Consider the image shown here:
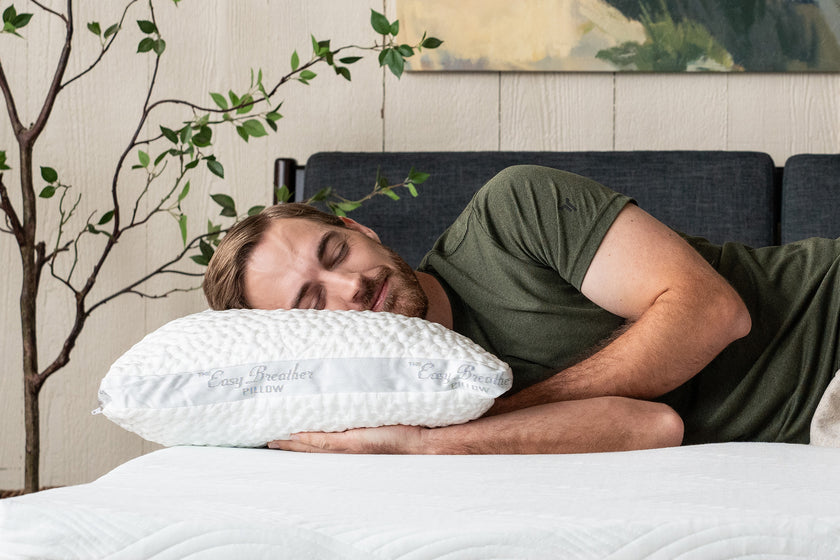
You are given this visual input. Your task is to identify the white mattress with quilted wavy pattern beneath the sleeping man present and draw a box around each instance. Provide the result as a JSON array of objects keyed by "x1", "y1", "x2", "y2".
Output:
[{"x1": 0, "y1": 443, "x2": 840, "y2": 560}]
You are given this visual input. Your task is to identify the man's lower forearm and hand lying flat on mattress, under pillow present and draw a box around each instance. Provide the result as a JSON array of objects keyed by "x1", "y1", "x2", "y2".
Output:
[{"x1": 269, "y1": 397, "x2": 683, "y2": 455}]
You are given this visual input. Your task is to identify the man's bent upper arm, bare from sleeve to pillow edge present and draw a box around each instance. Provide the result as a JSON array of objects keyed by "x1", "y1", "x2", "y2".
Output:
[{"x1": 491, "y1": 205, "x2": 751, "y2": 414}]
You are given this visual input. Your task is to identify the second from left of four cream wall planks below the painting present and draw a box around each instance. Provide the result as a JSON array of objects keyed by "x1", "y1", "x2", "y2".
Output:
[{"x1": 499, "y1": 73, "x2": 613, "y2": 151}]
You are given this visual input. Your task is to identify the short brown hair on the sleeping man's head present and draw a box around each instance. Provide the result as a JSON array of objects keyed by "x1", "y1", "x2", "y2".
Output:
[{"x1": 202, "y1": 202, "x2": 346, "y2": 310}]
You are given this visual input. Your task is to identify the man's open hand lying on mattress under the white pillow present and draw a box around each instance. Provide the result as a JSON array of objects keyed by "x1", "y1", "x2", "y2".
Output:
[{"x1": 268, "y1": 426, "x2": 428, "y2": 454}]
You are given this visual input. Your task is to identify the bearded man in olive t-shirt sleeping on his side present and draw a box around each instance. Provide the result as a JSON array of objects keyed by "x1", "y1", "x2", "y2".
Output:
[{"x1": 205, "y1": 166, "x2": 840, "y2": 453}]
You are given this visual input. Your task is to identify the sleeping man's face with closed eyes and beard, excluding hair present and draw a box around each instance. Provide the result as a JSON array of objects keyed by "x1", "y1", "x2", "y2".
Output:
[{"x1": 245, "y1": 218, "x2": 428, "y2": 317}]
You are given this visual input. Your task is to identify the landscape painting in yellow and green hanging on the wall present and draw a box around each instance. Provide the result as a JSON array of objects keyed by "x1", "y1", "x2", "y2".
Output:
[{"x1": 397, "y1": 0, "x2": 840, "y2": 72}]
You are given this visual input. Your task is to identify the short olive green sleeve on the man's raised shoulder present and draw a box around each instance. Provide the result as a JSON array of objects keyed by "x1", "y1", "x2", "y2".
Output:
[{"x1": 470, "y1": 165, "x2": 631, "y2": 290}]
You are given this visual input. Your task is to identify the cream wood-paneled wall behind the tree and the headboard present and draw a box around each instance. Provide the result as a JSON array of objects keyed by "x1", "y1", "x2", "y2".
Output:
[{"x1": 0, "y1": 0, "x2": 840, "y2": 488}]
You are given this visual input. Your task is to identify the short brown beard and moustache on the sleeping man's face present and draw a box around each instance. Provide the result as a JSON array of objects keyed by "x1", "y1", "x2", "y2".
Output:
[{"x1": 365, "y1": 245, "x2": 429, "y2": 319}]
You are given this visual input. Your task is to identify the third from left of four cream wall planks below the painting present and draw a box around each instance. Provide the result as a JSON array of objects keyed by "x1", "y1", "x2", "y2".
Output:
[{"x1": 615, "y1": 74, "x2": 726, "y2": 150}]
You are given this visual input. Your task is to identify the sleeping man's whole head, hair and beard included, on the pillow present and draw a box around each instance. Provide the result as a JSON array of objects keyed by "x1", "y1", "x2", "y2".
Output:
[{"x1": 204, "y1": 203, "x2": 428, "y2": 317}]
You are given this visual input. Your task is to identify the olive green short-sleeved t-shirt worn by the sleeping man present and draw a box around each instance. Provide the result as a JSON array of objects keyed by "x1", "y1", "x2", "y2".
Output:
[{"x1": 419, "y1": 166, "x2": 840, "y2": 443}]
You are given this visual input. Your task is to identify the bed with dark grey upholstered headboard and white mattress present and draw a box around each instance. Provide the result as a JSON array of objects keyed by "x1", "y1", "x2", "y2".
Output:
[{"x1": 0, "y1": 152, "x2": 840, "y2": 560}]
